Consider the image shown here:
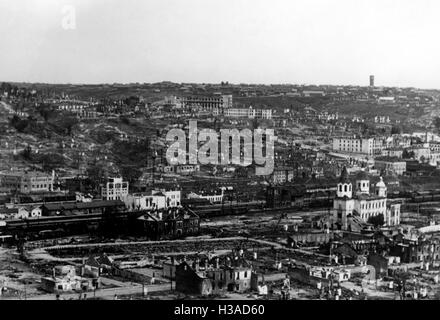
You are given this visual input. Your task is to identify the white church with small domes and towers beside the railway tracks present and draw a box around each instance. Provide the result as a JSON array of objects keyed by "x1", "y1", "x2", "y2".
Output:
[{"x1": 333, "y1": 168, "x2": 400, "y2": 231}]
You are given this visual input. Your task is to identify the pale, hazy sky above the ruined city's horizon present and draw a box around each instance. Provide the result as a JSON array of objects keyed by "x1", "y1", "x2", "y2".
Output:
[{"x1": 0, "y1": 0, "x2": 440, "y2": 89}]
